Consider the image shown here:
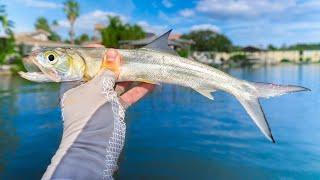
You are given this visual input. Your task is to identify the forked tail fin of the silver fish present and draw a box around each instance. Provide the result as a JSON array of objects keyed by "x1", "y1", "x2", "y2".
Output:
[{"x1": 236, "y1": 82, "x2": 310, "y2": 143}]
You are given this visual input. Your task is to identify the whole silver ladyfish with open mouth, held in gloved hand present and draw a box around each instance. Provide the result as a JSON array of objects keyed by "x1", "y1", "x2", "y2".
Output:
[{"x1": 20, "y1": 30, "x2": 309, "y2": 142}]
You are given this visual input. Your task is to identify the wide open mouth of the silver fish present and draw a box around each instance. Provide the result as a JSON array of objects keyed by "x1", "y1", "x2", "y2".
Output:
[{"x1": 19, "y1": 53, "x2": 61, "y2": 82}]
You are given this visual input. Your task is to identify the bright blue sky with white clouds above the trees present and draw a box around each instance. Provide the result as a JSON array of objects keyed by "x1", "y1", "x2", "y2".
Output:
[{"x1": 2, "y1": 0, "x2": 320, "y2": 46}]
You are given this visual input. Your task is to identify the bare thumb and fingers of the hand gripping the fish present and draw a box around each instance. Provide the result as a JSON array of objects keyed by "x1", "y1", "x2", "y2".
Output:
[{"x1": 90, "y1": 45, "x2": 155, "y2": 107}]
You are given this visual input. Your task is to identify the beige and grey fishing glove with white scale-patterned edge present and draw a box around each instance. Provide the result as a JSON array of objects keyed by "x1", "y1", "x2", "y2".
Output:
[{"x1": 42, "y1": 70, "x2": 126, "y2": 180}]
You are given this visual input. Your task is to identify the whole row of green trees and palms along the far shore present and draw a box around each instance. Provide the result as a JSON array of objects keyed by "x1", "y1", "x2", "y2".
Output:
[{"x1": 8, "y1": 0, "x2": 320, "y2": 64}]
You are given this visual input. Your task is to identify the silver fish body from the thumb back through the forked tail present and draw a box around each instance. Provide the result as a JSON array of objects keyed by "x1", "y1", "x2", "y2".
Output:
[{"x1": 70, "y1": 48, "x2": 308, "y2": 142}]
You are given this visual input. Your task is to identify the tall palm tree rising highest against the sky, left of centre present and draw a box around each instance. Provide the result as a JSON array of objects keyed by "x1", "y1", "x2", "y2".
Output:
[{"x1": 63, "y1": 0, "x2": 79, "y2": 44}]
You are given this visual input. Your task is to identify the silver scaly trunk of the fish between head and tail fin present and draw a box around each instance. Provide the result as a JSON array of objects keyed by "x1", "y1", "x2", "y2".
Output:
[{"x1": 75, "y1": 48, "x2": 242, "y2": 93}]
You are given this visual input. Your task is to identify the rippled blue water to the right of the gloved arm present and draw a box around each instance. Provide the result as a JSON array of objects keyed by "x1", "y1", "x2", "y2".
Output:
[{"x1": 118, "y1": 65, "x2": 320, "y2": 179}]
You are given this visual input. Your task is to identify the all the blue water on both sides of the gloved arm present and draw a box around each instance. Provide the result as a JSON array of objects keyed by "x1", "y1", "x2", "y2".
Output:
[{"x1": 0, "y1": 65, "x2": 320, "y2": 179}]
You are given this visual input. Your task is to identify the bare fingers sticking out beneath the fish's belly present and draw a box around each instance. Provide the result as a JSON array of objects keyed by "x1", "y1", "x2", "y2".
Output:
[{"x1": 120, "y1": 83, "x2": 155, "y2": 106}]
